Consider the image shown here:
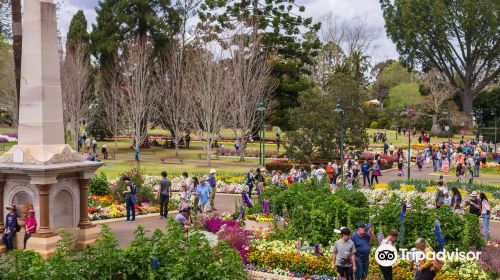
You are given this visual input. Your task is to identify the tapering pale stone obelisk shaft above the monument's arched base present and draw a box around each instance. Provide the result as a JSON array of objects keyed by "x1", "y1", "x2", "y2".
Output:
[{"x1": 0, "y1": 0, "x2": 85, "y2": 164}]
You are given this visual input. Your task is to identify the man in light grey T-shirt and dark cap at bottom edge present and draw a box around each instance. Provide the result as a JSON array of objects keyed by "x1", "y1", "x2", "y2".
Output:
[{"x1": 331, "y1": 227, "x2": 356, "y2": 280}]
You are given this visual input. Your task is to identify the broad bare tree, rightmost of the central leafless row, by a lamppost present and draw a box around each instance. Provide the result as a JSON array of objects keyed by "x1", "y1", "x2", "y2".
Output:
[{"x1": 226, "y1": 32, "x2": 276, "y2": 161}]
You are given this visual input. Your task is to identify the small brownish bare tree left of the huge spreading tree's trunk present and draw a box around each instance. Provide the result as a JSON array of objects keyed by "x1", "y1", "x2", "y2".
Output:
[{"x1": 423, "y1": 68, "x2": 455, "y2": 135}]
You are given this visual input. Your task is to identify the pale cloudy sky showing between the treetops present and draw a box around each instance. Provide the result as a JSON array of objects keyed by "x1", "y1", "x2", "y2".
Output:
[{"x1": 59, "y1": 0, "x2": 398, "y2": 61}]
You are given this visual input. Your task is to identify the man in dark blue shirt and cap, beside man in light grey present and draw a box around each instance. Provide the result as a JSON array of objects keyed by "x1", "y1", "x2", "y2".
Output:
[{"x1": 351, "y1": 223, "x2": 375, "y2": 280}]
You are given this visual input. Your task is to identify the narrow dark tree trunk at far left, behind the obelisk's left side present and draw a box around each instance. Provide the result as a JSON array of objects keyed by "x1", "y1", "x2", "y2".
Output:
[{"x1": 11, "y1": 0, "x2": 23, "y2": 124}]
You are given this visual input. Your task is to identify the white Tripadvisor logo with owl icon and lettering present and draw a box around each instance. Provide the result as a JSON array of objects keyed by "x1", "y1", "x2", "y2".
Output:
[{"x1": 375, "y1": 244, "x2": 481, "y2": 266}]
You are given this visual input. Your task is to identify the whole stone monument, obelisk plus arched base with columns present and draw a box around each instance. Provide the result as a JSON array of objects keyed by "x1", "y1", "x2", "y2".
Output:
[{"x1": 0, "y1": 0, "x2": 102, "y2": 256}]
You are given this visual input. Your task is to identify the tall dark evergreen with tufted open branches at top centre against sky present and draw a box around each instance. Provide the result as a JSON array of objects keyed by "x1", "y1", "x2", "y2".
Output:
[{"x1": 199, "y1": 0, "x2": 320, "y2": 129}]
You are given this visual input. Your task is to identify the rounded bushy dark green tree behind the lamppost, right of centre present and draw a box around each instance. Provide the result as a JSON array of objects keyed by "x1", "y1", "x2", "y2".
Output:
[{"x1": 287, "y1": 73, "x2": 368, "y2": 161}]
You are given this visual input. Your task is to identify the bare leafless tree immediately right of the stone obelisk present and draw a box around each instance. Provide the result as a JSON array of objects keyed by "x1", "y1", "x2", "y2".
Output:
[{"x1": 61, "y1": 44, "x2": 92, "y2": 149}]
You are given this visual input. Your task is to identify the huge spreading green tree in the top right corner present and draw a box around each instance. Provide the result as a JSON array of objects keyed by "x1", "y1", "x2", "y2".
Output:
[{"x1": 380, "y1": 0, "x2": 500, "y2": 127}]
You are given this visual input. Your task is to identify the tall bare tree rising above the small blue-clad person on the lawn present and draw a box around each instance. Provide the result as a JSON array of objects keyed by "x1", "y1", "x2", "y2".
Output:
[{"x1": 118, "y1": 38, "x2": 154, "y2": 163}]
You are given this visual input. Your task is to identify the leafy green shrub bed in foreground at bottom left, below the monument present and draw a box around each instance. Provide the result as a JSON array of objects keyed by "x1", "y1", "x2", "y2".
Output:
[{"x1": 0, "y1": 222, "x2": 246, "y2": 280}]
